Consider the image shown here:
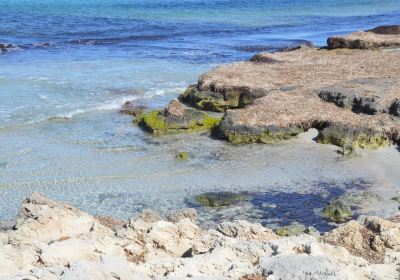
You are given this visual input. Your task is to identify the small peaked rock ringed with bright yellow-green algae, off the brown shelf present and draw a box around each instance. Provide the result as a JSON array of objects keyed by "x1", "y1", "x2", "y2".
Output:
[{"x1": 135, "y1": 100, "x2": 220, "y2": 135}]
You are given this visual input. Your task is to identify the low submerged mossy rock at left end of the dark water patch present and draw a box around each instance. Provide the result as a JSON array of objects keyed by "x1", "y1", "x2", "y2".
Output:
[{"x1": 196, "y1": 192, "x2": 249, "y2": 207}]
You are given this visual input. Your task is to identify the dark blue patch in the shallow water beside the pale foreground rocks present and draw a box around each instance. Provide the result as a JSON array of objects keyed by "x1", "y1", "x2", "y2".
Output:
[{"x1": 187, "y1": 180, "x2": 370, "y2": 233}]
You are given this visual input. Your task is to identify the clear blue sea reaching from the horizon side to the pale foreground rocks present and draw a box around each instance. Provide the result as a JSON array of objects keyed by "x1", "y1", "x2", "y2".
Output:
[{"x1": 0, "y1": 0, "x2": 400, "y2": 231}]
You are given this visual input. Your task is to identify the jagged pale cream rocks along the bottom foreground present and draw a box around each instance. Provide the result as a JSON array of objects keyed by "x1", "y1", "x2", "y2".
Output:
[{"x1": 0, "y1": 193, "x2": 400, "y2": 280}]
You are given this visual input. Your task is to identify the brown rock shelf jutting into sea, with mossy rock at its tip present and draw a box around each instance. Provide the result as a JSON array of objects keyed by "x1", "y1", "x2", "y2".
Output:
[{"x1": 129, "y1": 26, "x2": 400, "y2": 154}]
